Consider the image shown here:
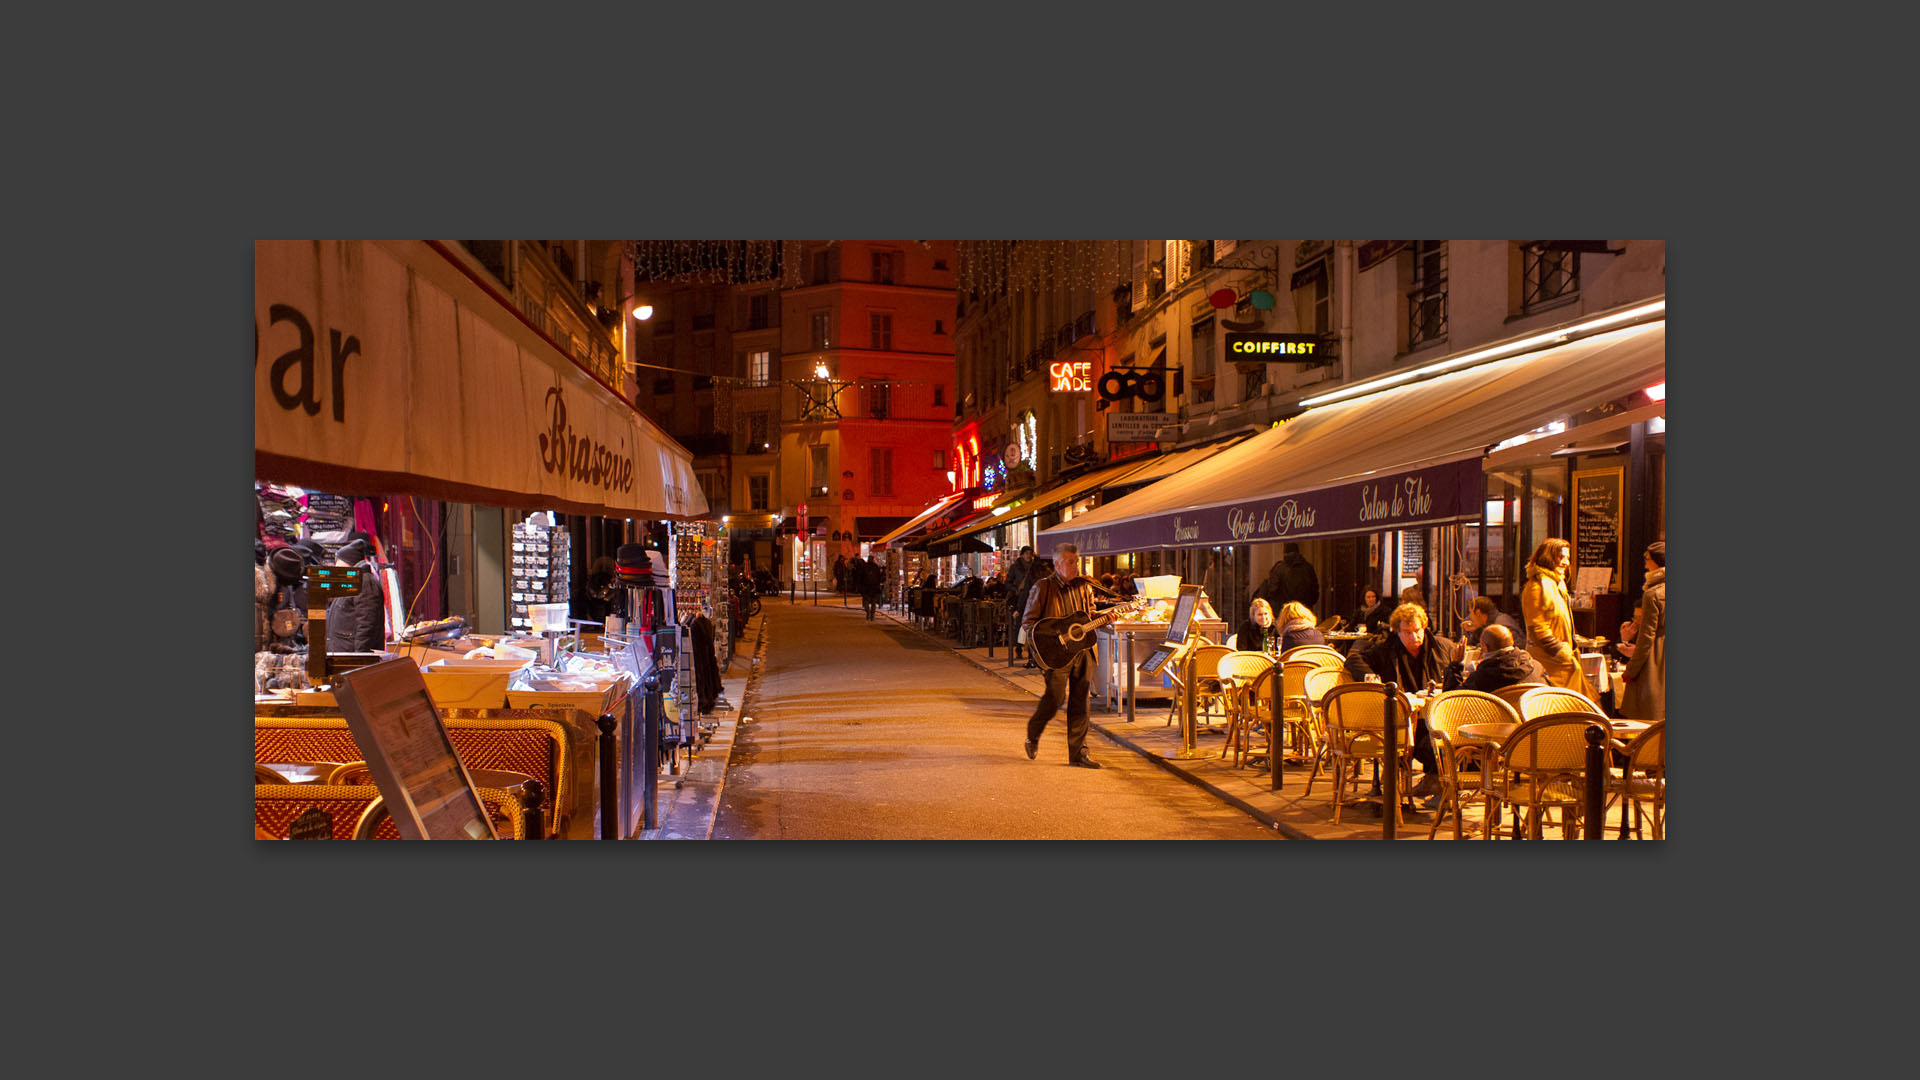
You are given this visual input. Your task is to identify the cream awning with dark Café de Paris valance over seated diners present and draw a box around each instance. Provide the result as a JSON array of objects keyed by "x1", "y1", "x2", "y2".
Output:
[{"x1": 1035, "y1": 319, "x2": 1667, "y2": 555}]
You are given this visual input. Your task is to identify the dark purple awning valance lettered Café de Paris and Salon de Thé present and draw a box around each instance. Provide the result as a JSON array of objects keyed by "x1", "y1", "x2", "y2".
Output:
[{"x1": 1044, "y1": 457, "x2": 1486, "y2": 555}]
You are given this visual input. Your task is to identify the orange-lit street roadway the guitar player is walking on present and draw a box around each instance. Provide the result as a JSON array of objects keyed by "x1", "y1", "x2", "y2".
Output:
[{"x1": 706, "y1": 598, "x2": 1277, "y2": 840}]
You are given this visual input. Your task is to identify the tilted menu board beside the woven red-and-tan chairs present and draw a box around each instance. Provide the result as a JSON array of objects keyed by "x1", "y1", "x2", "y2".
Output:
[{"x1": 334, "y1": 659, "x2": 497, "y2": 840}]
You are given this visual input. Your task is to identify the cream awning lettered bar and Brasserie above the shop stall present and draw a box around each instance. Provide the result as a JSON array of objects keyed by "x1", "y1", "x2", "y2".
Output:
[{"x1": 253, "y1": 240, "x2": 707, "y2": 519}]
